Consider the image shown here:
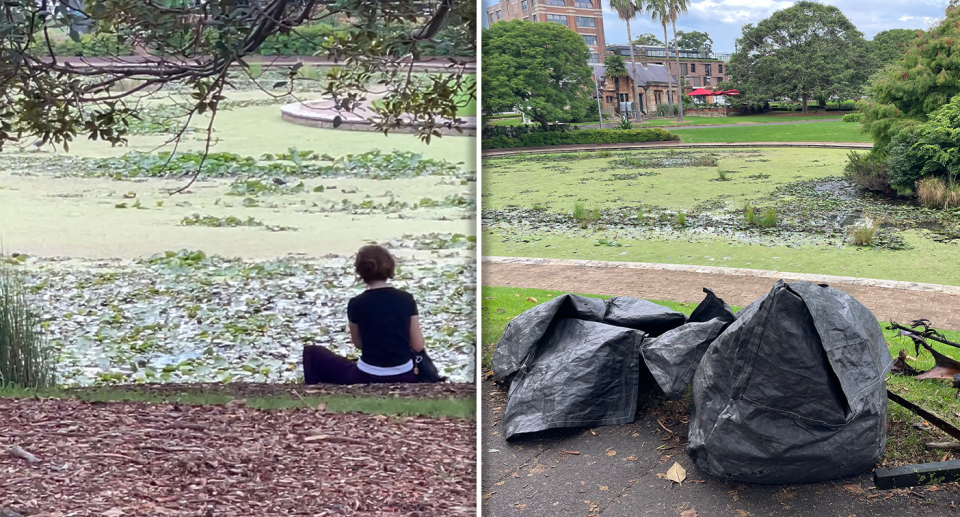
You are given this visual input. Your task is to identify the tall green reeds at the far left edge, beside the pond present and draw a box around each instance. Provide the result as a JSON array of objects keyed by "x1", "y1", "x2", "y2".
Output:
[{"x1": 0, "y1": 262, "x2": 56, "y2": 389}]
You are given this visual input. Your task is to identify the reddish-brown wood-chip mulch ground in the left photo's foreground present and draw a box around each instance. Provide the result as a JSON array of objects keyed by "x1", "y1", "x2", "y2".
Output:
[{"x1": 0, "y1": 399, "x2": 477, "y2": 517}]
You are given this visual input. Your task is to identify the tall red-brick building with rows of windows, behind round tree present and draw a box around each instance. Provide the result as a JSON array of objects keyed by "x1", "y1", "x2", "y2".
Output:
[{"x1": 486, "y1": 0, "x2": 606, "y2": 63}]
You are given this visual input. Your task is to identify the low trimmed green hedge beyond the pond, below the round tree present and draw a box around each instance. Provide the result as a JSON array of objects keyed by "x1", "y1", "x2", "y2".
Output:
[{"x1": 481, "y1": 128, "x2": 680, "y2": 149}]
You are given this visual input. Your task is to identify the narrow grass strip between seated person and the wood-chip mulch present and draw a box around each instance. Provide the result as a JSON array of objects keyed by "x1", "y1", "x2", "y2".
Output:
[{"x1": 0, "y1": 387, "x2": 476, "y2": 419}]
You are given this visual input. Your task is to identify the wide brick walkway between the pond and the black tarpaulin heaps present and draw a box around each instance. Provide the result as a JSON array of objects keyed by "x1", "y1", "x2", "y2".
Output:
[{"x1": 481, "y1": 257, "x2": 960, "y2": 330}]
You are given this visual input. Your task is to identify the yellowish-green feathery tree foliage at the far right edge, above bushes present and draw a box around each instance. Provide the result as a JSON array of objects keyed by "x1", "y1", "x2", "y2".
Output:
[{"x1": 860, "y1": 7, "x2": 960, "y2": 154}]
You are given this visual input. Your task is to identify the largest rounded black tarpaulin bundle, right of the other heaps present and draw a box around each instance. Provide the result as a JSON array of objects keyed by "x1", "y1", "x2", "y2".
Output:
[{"x1": 687, "y1": 281, "x2": 893, "y2": 484}]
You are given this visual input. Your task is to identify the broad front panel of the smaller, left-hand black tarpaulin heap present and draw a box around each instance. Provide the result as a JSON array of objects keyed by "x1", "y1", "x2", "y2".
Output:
[{"x1": 503, "y1": 318, "x2": 643, "y2": 439}]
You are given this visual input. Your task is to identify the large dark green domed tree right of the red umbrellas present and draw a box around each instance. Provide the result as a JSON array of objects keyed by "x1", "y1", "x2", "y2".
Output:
[{"x1": 728, "y1": 1, "x2": 875, "y2": 113}]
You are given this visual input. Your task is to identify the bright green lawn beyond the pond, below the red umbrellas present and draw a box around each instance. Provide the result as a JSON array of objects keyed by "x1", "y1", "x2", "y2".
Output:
[{"x1": 671, "y1": 122, "x2": 872, "y2": 142}]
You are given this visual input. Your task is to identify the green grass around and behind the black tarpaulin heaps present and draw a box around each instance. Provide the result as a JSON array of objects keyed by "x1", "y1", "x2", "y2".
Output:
[{"x1": 481, "y1": 286, "x2": 960, "y2": 465}]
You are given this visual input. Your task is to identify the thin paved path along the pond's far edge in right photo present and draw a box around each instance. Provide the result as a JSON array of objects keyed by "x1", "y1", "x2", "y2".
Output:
[{"x1": 481, "y1": 141, "x2": 873, "y2": 158}]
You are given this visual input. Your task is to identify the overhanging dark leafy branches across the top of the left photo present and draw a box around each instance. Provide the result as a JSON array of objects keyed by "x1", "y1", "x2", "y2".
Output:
[{"x1": 0, "y1": 0, "x2": 476, "y2": 153}]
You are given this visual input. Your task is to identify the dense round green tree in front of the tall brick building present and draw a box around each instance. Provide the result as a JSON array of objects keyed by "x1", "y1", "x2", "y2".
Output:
[{"x1": 480, "y1": 20, "x2": 594, "y2": 129}]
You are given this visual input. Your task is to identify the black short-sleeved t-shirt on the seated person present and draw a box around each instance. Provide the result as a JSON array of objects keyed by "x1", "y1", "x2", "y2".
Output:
[{"x1": 347, "y1": 287, "x2": 419, "y2": 368}]
